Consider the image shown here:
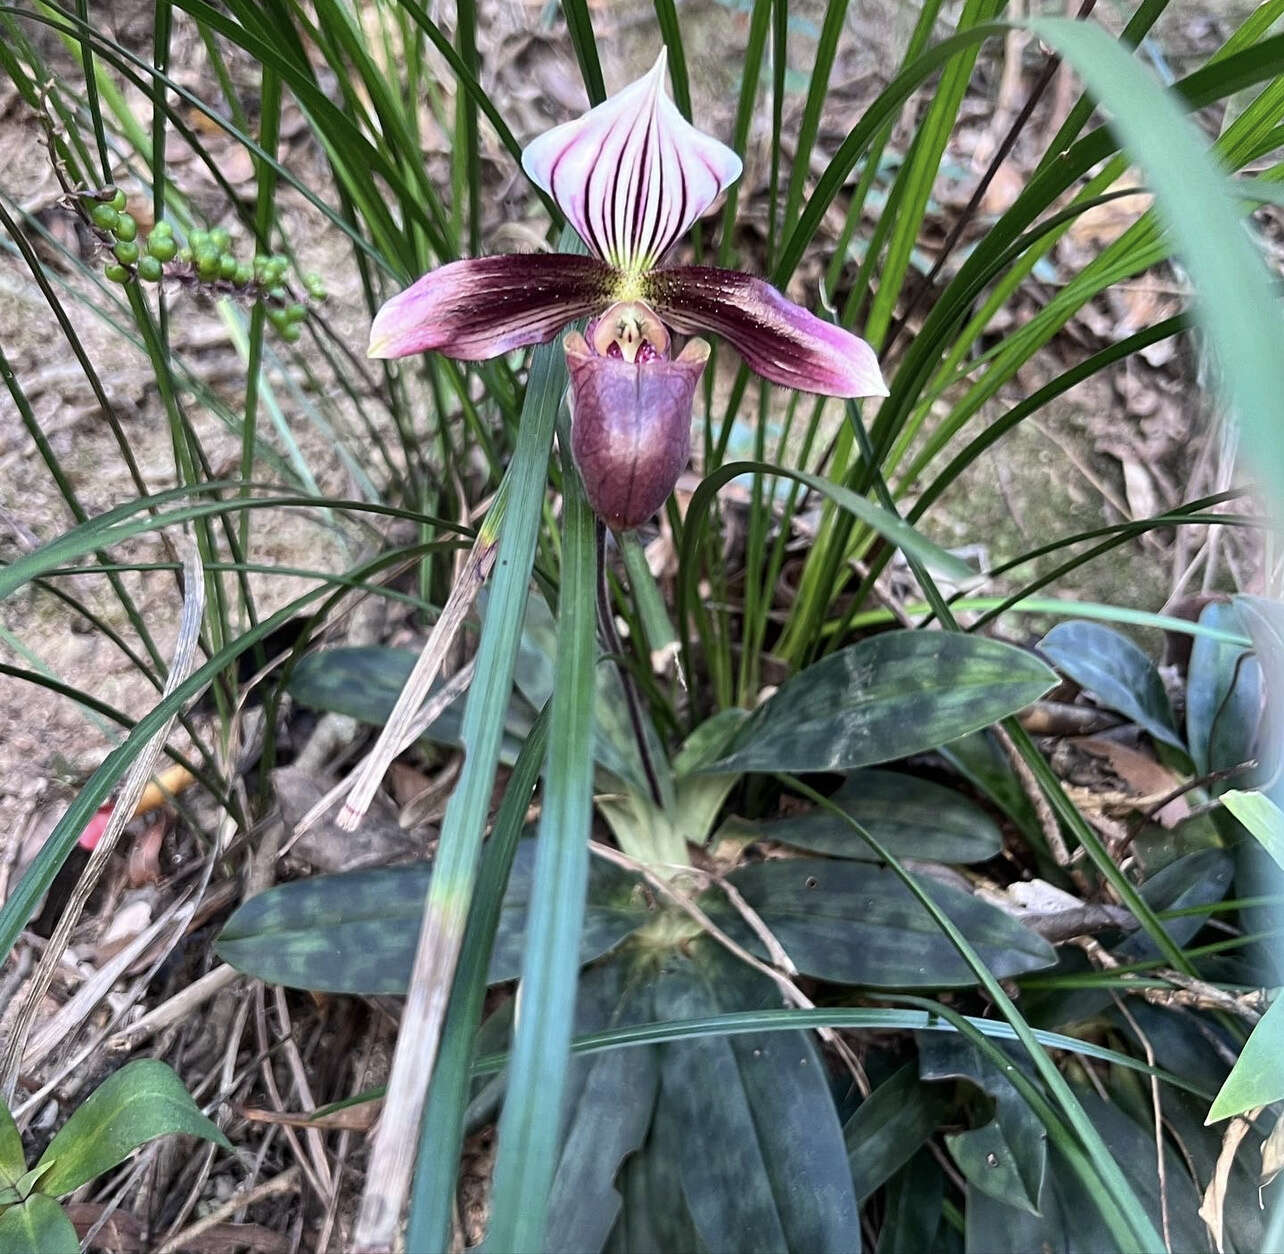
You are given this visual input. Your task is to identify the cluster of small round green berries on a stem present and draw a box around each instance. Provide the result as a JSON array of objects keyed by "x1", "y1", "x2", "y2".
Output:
[{"x1": 86, "y1": 187, "x2": 326, "y2": 344}]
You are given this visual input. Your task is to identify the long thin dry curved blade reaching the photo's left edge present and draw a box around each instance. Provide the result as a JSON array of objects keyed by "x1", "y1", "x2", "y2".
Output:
[{"x1": 0, "y1": 543, "x2": 205, "y2": 1104}]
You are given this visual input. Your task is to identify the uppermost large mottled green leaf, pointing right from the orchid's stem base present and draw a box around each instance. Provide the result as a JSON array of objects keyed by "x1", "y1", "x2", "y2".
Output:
[{"x1": 709, "y1": 631, "x2": 1057, "y2": 771}]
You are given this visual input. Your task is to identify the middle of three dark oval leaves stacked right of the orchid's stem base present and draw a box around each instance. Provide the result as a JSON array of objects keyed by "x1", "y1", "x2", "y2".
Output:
[{"x1": 737, "y1": 770, "x2": 1003, "y2": 863}]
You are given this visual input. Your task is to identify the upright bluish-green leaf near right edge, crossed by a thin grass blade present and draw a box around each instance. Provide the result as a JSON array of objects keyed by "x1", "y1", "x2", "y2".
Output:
[{"x1": 1186, "y1": 601, "x2": 1262, "y2": 787}]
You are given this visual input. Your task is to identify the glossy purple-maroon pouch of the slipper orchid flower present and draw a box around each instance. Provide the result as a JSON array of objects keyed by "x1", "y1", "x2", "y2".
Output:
[{"x1": 566, "y1": 331, "x2": 709, "y2": 531}]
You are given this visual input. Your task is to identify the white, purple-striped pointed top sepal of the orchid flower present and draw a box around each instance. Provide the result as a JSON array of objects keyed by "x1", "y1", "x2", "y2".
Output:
[{"x1": 521, "y1": 50, "x2": 741, "y2": 271}]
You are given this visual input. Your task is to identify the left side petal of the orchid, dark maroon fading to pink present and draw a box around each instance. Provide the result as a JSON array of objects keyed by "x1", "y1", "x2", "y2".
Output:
[{"x1": 369, "y1": 253, "x2": 619, "y2": 362}]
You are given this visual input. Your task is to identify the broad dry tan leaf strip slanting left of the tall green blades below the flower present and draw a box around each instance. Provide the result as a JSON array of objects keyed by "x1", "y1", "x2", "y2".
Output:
[{"x1": 338, "y1": 515, "x2": 499, "y2": 832}]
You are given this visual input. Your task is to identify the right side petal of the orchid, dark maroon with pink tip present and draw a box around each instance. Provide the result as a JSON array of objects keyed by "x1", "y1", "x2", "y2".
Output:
[{"x1": 642, "y1": 266, "x2": 887, "y2": 397}]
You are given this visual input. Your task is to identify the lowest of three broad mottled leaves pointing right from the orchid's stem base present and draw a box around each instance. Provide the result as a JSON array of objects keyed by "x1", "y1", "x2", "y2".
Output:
[{"x1": 701, "y1": 857, "x2": 1057, "y2": 988}]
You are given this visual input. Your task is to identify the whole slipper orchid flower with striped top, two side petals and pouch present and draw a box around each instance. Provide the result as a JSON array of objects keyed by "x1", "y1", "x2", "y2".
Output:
[{"x1": 370, "y1": 51, "x2": 887, "y2": 530}]
